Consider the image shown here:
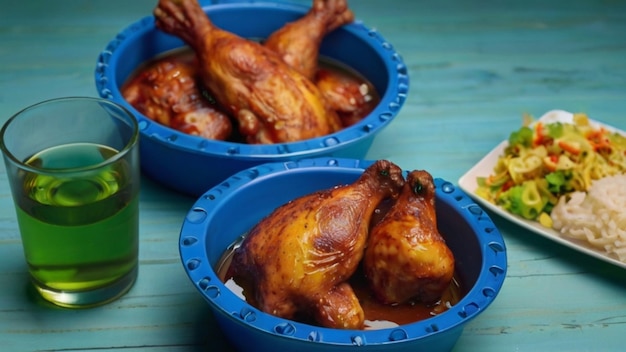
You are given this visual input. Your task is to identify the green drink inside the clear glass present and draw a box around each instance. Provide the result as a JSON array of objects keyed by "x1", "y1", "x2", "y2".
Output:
[{"x1": 16, "y1": 143, "x2": 138, "y2": 291}]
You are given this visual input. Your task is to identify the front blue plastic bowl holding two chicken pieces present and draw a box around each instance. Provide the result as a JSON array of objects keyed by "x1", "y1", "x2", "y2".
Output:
[{"x1": 179, "y1": 158, "x2": 507, "y2": 351}]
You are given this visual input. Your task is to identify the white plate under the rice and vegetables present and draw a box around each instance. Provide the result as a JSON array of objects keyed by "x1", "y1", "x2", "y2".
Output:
[{"x1": 459, "y1": 110, "x2": 626, "y2": 269}]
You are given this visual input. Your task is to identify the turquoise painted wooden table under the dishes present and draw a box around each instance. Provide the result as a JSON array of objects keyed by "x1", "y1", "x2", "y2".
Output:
[{"x1": 0, "y1": 0, "x2": 626, "y2": 352}]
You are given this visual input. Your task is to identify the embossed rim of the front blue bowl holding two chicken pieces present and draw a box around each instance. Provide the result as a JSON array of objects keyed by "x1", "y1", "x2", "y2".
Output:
[{"x1": 179, "y1": 157, "x2": 507, "y2": 346}]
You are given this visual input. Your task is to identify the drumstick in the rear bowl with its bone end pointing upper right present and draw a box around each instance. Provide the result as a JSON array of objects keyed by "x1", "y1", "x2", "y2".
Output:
[{"x1": 264, "y1": 0, "x2": 354, "y2": 80}]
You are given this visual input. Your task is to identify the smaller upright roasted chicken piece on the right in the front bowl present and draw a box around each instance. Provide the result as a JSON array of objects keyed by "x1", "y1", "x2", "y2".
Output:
[{"x1": 363, "y1": 171, "x2": 454, "y2": 304}]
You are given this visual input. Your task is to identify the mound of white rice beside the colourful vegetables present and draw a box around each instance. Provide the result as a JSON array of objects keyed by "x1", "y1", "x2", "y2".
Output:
[{"x1": 550, "y1": 174, "x2": 626, "y2": 262}]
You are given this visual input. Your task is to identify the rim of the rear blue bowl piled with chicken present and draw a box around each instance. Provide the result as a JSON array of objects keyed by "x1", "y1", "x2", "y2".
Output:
[{"x1": 95, "y1": 2, "x2": 409, "y2": 160}]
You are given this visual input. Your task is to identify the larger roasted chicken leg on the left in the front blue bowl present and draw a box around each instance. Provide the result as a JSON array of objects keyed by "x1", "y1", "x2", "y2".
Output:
[{"x1": 229, "y1": 160, "x2": 404, "y2": 329}]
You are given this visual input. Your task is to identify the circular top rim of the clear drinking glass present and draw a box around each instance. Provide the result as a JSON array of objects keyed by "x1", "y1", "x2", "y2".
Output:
[{"x1": 0, "y1": 96, "x2": 139, "y2": 174}]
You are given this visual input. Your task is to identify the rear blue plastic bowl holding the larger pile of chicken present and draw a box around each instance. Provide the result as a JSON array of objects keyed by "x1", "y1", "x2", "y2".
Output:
[{"x1": 95, "y1": 2, "x2": 409, "y2": 196}]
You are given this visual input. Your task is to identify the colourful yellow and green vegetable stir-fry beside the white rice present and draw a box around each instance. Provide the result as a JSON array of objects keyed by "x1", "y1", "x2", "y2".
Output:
[{"x1": 476, "y1": 113, "x2": 626, "y2": 227}]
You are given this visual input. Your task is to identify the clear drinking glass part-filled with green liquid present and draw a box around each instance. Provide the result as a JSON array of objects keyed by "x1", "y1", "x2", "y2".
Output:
[{"x1": 0, "y1": 97, "x2": 140, "y2": 308}]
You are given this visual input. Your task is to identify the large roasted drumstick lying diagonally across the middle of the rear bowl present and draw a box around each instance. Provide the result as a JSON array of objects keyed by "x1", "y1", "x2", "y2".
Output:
[{"x1": 154, "y1": 0, "x2": 341, "y2": 143}]
